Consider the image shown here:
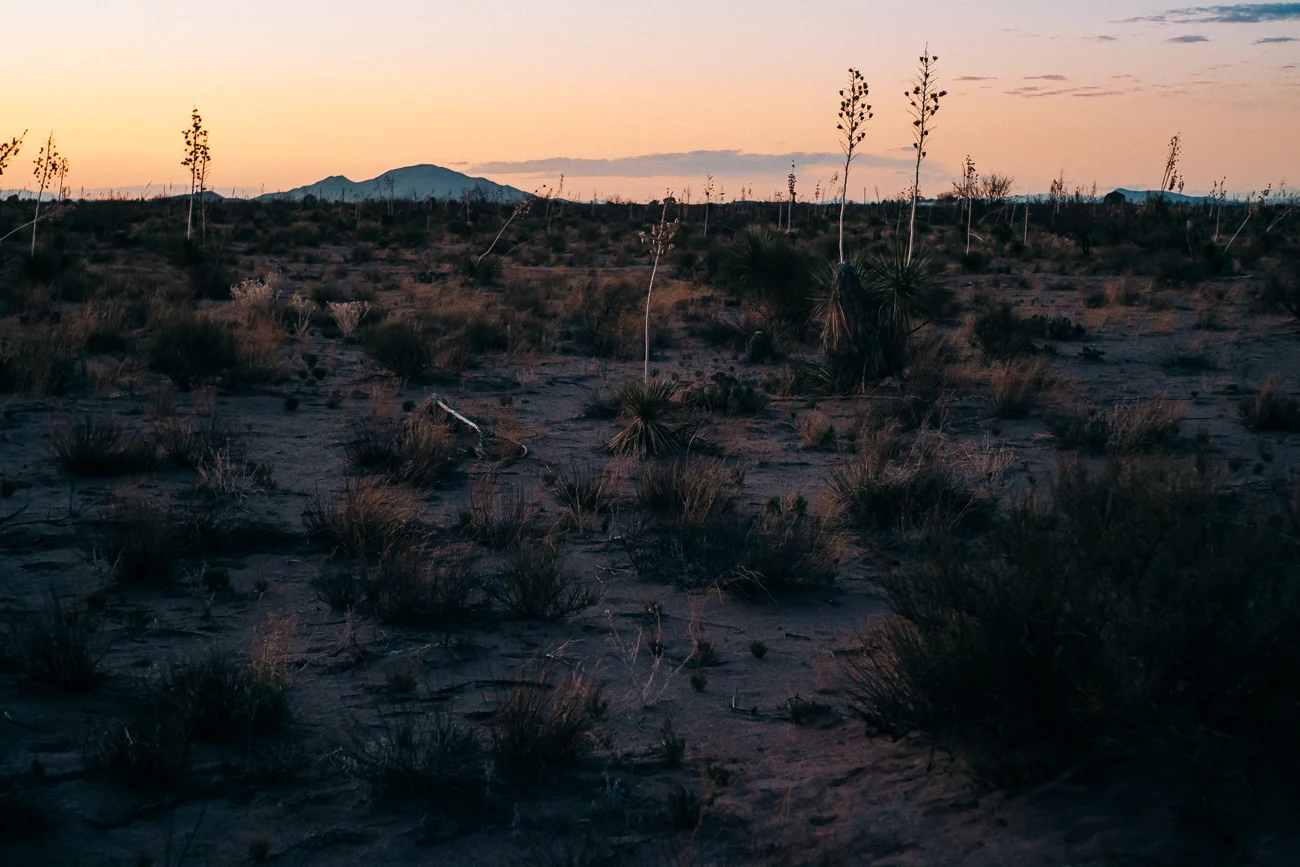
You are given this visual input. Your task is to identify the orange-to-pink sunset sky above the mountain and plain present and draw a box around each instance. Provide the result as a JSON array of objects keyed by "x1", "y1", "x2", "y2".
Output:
[{"x1": 0, "y1": 0, "x2": 1300, "y2": 200}]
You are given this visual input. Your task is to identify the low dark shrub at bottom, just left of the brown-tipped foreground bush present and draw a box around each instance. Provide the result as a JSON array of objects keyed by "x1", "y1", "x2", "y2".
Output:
[{"x1": 343, "y1": 710, "x2": 485, "y2": 801}]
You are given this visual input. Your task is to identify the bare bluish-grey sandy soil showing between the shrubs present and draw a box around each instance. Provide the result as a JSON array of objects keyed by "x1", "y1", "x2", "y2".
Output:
[{"x1": 0, "y1": 266, "x2": 1300, "y2": 867}]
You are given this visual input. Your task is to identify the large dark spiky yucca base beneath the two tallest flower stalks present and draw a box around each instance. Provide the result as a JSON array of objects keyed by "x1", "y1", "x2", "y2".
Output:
[{"x1": 818, "y1": 247, "x2": 948, "y2": 389}]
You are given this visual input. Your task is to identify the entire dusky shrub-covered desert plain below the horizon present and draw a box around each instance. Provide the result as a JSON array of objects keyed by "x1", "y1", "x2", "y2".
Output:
[{"x1": 0, "y1": 198, "x2": 1300, "y2": 867}]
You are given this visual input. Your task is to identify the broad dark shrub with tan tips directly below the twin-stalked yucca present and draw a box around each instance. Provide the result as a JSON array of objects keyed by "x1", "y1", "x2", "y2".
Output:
[{"x1": 827, "y1": 434, "x2": 993, "y2": 534}]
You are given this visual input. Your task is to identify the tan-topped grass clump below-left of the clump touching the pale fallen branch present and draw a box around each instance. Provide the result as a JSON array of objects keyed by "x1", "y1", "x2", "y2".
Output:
[{"x1": 303, "y1": 478, "x2": 420, "y2": 556}]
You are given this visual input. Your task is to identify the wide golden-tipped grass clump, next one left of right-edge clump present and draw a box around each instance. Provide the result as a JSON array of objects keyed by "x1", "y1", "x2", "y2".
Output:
[{"x1": 1047, "y1": 398, "x2": 1183, "y2": 455}]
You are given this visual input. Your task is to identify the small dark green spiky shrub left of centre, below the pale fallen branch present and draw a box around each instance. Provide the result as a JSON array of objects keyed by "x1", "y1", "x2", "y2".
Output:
[{"x1": 493, "y1": 539, "x2": 601, "y2": 620}]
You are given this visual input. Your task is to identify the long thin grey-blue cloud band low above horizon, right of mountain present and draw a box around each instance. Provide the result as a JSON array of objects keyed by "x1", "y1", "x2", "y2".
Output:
[{"x1": 472, "y1": 148, "x2": 910, "y2": 178}]
